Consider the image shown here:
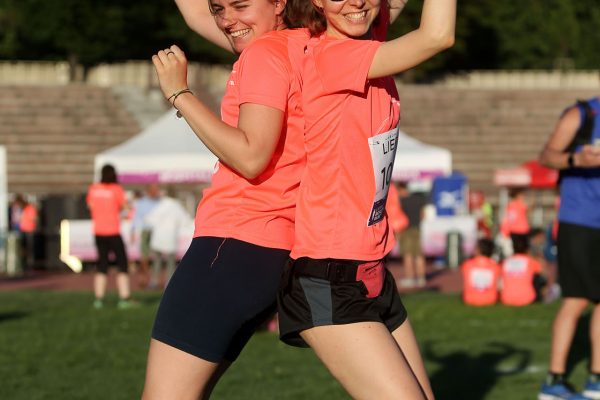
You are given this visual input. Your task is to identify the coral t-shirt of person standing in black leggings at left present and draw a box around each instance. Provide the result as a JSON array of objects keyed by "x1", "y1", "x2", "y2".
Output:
[{"x1": 86, "y1": 183, "x2": 125, "y2": 236}]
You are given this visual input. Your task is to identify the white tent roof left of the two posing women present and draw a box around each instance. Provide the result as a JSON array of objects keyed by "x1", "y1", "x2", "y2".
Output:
[{"x1": 94, "y1": 110, "x2": 217, "y2": 183}]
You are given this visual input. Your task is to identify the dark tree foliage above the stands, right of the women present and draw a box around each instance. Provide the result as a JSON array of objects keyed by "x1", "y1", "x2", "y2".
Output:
[{"x1": 390, "y1": 0, "x2": 600, "y2": 79}]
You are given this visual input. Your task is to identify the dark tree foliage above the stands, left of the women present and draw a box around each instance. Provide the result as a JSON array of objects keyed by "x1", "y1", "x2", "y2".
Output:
[{"x1": 0, "y1": 0, "x2": 232, "y2": 67}]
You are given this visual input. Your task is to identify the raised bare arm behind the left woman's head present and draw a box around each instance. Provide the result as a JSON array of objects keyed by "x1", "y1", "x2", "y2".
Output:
[{"x1": 175, "y1": 0, "x2": 233, "y2": 53}]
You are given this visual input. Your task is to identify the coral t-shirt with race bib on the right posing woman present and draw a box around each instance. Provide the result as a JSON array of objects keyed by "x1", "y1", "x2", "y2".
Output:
[{"x1": 291, "y1": 7, "x2": 400, "y2": 261}]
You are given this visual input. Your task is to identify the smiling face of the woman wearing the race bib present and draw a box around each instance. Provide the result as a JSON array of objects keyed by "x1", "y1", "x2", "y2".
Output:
[{"x1": 313, "y1": 0, "x2": 381, "y2": 38}]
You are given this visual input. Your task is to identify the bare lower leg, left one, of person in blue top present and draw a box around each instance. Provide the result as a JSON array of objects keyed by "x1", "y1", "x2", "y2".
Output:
[{"x1": 550, "y1": 297, "x2": 588, "y2": 374}]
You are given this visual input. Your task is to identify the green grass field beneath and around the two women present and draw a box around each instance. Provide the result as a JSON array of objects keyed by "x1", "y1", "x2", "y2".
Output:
[{"x1": 0, "y1": 291, "x2": 589, "y2": 400}]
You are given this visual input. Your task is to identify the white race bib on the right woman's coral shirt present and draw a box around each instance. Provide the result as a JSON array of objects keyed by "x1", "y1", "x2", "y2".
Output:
[{"x1": 367, "y1": 127, "x2": 398, "y2": 226}]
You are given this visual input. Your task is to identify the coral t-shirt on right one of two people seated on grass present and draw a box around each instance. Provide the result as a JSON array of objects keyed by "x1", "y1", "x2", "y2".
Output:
[{"x1": 500, "y1": 254, "x2": 542, "y2": 306}]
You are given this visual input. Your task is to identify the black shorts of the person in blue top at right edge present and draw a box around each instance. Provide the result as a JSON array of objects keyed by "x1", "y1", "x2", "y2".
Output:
[{"x1": 557, "y1": 222, "x2": 600, "y2": 303}]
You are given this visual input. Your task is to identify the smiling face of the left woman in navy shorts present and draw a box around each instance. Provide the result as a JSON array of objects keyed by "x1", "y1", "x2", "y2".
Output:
[{"x1": 209, "y1": 0, "x2": 286, "y2": 53}]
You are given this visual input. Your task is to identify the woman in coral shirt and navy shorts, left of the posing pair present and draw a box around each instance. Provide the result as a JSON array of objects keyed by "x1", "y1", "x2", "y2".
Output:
[{"x1": 143, "y1": 0, "x2": 328, "y2": 400}]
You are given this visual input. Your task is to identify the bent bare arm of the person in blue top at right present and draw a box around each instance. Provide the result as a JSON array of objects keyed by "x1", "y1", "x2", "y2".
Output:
[{"x1": 539, "y1": 107, "x2": 600, "y2": 169}]
